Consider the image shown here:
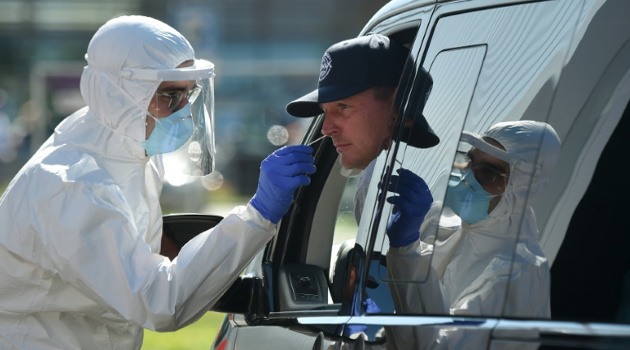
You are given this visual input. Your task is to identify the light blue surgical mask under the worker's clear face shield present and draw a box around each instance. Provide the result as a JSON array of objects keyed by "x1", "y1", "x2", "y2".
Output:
[{"x1": 142, "y1": 103, "x2": 193, "y2": 156}]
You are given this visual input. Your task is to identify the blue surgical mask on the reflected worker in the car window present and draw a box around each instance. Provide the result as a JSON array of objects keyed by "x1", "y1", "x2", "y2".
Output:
[{"x1": 444, "y1": 169, "x2": 495, "y2": 224}]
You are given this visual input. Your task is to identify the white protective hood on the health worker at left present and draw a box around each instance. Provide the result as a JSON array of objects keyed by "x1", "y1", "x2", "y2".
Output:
[{"x1": 81, "y1": 16, "x2": 195, "y2": 158}]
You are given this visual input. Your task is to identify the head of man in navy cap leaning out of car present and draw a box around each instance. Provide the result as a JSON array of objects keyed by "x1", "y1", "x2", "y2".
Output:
[{"x1": 286, "y1": 34, "x2": 439, "y2": 170}]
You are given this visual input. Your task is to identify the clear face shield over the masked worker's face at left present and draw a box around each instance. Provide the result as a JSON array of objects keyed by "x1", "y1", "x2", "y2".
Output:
[{"x1": 128, "y1": 60, "x2": 216, "y2": 177}]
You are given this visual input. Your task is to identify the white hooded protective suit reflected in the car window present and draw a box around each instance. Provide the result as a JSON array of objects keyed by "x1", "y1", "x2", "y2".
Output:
[{"x1": 387, "y1": 121, "x2": 560, "y2": 349}]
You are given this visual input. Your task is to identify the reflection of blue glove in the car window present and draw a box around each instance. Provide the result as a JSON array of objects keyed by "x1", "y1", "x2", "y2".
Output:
[{"x1": 387, "y1": 168, "x2": 433, "y2": 247}]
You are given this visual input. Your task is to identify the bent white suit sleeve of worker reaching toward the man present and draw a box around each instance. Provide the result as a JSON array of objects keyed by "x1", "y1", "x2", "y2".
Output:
[{"x1": 40, "y1": 182, "x2": 275, "y2": 331}]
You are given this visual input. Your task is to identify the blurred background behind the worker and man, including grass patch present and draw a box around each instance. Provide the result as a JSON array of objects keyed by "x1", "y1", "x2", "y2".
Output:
[{"x1": 0, "y1": 0, "x2": 387, "y2": 350}]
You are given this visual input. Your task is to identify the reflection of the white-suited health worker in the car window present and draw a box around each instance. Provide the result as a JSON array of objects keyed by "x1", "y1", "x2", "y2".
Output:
[{"x1": 387, "y1": 121, "x2": 560, "y2": 349}]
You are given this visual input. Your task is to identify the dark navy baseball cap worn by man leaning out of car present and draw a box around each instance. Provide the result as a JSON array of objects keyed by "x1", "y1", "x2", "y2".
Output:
[{"x1": 286, "y1": 34, "x2": 439, "y2": 148}]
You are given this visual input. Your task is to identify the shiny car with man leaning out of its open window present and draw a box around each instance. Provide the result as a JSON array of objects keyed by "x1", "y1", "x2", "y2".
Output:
[{"x1": 169, "y1": 0, "x2": 630, "y2": 350}]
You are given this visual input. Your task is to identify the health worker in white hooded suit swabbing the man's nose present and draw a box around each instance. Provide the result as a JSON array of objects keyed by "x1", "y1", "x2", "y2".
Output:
[{"x1": 0, "y1": 16, "x2": 315, "y2": 350}]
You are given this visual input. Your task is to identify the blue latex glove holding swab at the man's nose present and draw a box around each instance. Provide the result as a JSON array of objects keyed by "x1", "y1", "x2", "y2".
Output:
[{"x1": 250, "y1": 145, "x2": 315, "y2": 224}]
